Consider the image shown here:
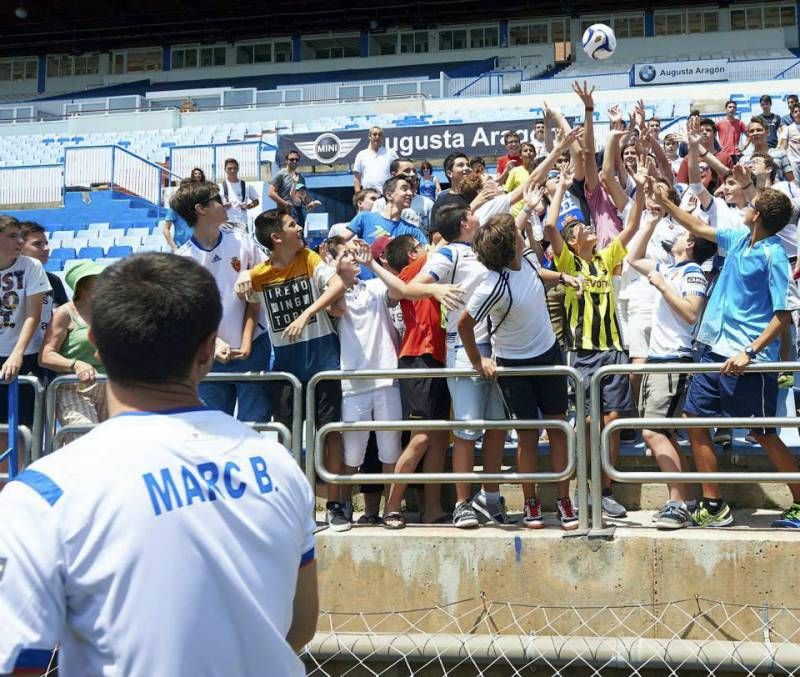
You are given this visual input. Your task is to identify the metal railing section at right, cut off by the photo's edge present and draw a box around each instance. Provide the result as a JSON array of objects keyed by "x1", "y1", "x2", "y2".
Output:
[{"x1": 581, "y1": 362, "x2": 800, "y2": 530}]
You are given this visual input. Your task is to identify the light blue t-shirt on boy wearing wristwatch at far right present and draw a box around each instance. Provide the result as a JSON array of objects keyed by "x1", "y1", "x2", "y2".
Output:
[{"x1": 697, "y1": 228, "x2": 789, "y2": 362}]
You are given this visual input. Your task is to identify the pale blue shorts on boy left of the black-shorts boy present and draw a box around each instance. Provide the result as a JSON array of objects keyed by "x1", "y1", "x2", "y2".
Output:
[{"x1": 447, "y1": 345, "x2": 509, "y2": 440}]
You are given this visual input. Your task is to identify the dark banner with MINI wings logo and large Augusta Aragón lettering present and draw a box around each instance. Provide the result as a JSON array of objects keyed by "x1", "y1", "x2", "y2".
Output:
[{"x1": 278, "y1": 117, "x2": 556, "y2": 165}]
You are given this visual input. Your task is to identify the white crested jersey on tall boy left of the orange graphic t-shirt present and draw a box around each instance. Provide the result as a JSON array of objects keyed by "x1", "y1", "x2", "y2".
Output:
[{"x1": 176, "y1": 230, "x2": 267, "y2": 348}]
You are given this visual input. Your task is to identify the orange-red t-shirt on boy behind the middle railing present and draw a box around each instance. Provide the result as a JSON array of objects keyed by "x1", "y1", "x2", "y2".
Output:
[{"x1": 399, "y1": 256, "x2": 447, "y2": 364}]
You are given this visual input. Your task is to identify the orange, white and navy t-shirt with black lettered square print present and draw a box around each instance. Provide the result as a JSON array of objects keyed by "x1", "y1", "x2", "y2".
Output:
[{"x1": 250, "y1": 249, "x2": 339, "y2": 381}]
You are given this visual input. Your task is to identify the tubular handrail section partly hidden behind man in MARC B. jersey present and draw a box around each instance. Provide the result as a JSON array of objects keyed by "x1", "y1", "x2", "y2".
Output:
[{"x1": 44, "y1": 371, "x2": 303, "y2": 467}]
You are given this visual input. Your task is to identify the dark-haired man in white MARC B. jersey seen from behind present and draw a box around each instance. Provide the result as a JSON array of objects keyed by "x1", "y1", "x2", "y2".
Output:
[{"x1": 0, "y1": 254, "x2": 318, "y2": 677}]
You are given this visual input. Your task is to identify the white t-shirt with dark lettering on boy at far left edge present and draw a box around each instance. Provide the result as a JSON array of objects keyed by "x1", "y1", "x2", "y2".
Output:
[{"x1": 0, "y1": 256, "x2": 51, "y2": 357}]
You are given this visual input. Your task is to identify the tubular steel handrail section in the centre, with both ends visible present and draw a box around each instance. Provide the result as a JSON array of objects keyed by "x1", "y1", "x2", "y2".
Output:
[{"x1": 306, "y1": 365, "x2": 588, "y2": 530}]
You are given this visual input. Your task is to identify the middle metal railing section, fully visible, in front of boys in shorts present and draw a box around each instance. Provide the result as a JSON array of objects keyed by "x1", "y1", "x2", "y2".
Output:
[{"x1": 306, "y1": 365, "x2": 588, "y2": 530}]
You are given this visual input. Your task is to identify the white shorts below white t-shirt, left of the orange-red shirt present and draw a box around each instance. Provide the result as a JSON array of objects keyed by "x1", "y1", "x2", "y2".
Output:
[{"x1": 342, "y1": 386, "x2": 403, "y2": 468}]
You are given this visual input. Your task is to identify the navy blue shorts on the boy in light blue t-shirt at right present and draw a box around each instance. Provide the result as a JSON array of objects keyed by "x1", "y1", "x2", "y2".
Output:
[{"x1": 683, "y1": 351, "x2": 778, "y2": 434}]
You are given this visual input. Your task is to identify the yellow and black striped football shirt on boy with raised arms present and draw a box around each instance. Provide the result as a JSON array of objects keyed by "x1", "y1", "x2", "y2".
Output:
[{"x1": 555, "y1": 237, "x2": 627, "y2": 350}]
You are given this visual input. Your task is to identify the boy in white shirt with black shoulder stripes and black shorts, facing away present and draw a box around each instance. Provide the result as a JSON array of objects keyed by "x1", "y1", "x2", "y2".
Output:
[{"x1": 458, "y1": 214, "x2": 579, "y2": 529}]
